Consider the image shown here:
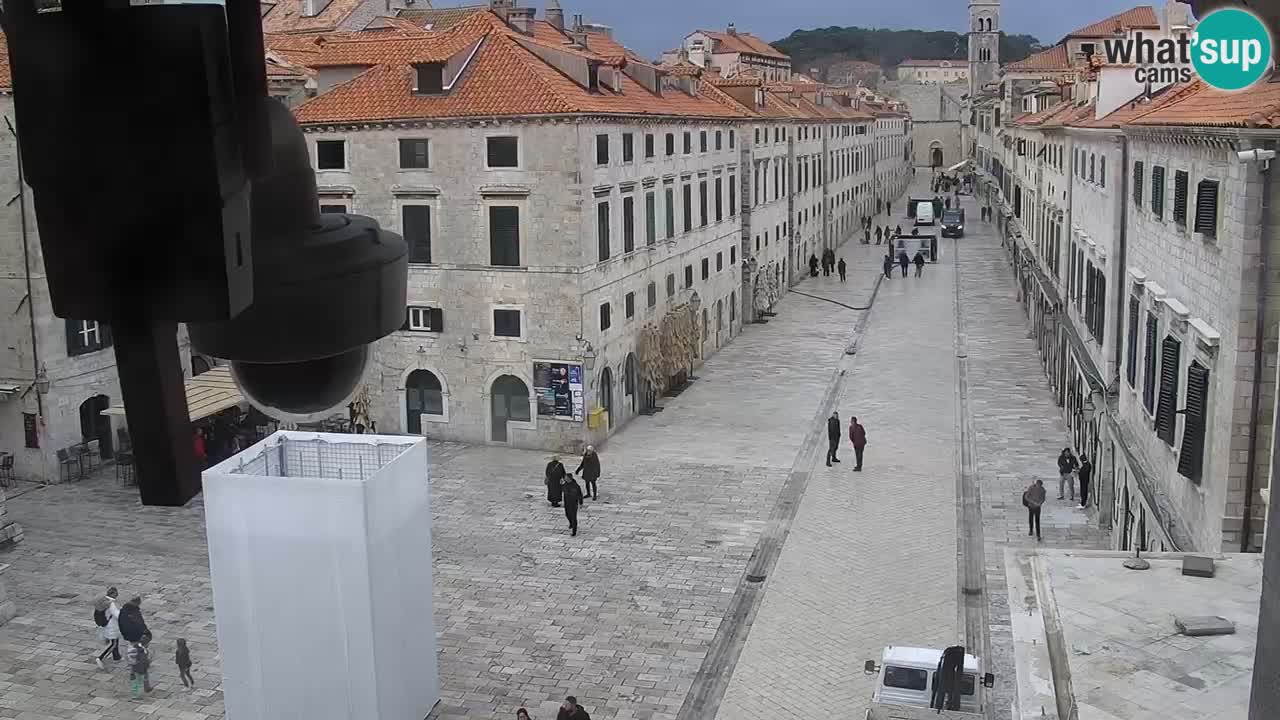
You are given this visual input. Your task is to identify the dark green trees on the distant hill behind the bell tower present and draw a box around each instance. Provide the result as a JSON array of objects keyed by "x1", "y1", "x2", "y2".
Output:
[{"x1": 773, "y1": 26, "x2": 1042, "y2": 77}]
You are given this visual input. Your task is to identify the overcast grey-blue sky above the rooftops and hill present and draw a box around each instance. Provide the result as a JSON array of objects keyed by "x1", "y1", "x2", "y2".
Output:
[{"x1": 463, "y1": 0, "x2": 1164, "y2": 56}]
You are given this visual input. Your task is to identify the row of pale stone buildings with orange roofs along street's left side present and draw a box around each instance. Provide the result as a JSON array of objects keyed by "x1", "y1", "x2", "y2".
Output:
[{"x1": 284, "y1": 5, "x2": 905, "y2": 451}]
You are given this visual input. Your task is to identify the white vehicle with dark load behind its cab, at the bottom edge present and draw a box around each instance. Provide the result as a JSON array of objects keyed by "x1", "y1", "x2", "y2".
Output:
[{"x1": 864, "y1": 646, "x2": 996, "y2": 720}]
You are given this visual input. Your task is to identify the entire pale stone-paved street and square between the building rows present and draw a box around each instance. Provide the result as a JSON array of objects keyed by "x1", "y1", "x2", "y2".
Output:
[{"x1": 0, "y1": 173, "x2": 1094, "y2": 720}]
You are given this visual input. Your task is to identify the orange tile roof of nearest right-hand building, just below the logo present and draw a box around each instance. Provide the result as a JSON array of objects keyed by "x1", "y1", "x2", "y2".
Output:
[{"x1": 1129, "y1": 81, "x2": 1280, "y2": 129}]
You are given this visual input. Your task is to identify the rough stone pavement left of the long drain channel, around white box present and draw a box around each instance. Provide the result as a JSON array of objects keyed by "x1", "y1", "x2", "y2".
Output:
[{"x1": 0, "y1": 225, "x2": 879, "y2": 720}]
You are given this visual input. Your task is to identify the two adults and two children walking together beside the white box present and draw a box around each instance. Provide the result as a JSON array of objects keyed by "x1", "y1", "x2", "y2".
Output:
[{"x1": 93, "y1": 588, "x2": 196, "y2": 700}]
